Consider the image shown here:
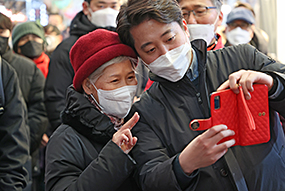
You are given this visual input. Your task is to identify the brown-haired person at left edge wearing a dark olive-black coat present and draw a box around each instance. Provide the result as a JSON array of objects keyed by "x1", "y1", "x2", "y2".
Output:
[{"x1": 0, "y1": 13, "x2": 48, "y2": 190}]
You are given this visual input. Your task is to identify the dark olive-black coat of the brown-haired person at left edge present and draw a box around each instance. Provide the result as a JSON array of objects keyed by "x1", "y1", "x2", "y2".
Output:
[{"x1": 3, "y1": 49, "x2": 48, "y2": 153}]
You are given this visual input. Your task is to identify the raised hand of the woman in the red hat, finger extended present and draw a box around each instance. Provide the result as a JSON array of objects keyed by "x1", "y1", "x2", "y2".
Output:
[{"x1": 112, "y1": 112, "x2": 140, "y2": 154}]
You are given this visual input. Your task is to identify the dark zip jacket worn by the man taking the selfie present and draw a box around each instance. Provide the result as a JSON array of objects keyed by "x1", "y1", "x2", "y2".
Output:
[{"x1": 129, "y1": 41, "x2": 285, "y2": 191}]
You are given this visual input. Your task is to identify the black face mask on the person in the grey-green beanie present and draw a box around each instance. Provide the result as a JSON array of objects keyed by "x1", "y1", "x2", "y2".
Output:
[{"x1": 19, "y1": 41, "x2": 43, "y2": 59}]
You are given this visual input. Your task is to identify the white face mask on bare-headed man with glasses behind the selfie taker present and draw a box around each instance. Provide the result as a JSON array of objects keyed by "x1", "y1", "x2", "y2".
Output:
[{"x1": 187, "y1": 15, "x2": 219, "y2": 46}]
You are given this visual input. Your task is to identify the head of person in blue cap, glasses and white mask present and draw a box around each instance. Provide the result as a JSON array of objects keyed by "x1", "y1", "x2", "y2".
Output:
[{"x1": 225, "y1": 7, "x2": 255, "y2": 46}]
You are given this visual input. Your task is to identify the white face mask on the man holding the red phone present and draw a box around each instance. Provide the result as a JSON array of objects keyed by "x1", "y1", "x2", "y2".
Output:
[{"x1": 139, "y1": 43, "x2": 192, "y2": 82}]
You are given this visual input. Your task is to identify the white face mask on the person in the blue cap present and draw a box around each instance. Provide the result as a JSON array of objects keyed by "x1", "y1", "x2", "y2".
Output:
[{"x1": 226, "y1": 27, "x2": 251, "y2": 45}]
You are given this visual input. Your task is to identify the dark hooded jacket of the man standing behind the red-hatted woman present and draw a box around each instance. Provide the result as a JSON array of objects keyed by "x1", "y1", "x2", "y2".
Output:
[{"x1": 45, "y1": 11, "x2": 115, "y2": 135}]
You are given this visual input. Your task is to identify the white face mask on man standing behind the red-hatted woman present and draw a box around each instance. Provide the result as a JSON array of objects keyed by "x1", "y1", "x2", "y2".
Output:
[{"x1": 88, "y1": 7, "x2": 119, "y2": 28}]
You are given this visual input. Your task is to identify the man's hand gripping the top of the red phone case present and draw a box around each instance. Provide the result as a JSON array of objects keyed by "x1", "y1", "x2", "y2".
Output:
[{"x1": 218, "y1": 70, "x2": 273, "y2": 100}]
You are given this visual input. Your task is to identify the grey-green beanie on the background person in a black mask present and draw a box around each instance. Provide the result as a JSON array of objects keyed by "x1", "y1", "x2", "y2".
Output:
[{"x1": 12, "y1": 21, "x2": 46, "y2": 52}]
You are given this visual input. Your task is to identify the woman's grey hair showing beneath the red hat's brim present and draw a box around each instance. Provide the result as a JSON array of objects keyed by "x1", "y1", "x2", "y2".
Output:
[{"x1": 88, "y1": 56, "x2": 138, "y2": 84}]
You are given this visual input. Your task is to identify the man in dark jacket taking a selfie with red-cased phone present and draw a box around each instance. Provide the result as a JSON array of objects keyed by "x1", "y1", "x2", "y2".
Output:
[{"x1": 117, "y1": 0, "x2": 285, "y2": 191}]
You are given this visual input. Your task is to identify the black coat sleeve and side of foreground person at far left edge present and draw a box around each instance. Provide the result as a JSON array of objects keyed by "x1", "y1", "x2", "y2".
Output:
[{"x1": 0, "y1": 58, "x2": 30, "y2": 191}]
